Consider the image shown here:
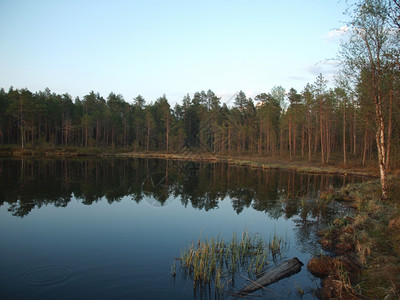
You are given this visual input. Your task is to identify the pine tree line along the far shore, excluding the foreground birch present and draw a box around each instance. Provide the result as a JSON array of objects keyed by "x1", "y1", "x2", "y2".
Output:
[{"x1": 0, "y1": 69, "x2": 400, "y2": 168}]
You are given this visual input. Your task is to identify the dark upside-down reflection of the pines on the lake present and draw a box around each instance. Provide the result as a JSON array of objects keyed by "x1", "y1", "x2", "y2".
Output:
[{"x1": 0, "y1": 158, "x2": 359, "y2": 218}]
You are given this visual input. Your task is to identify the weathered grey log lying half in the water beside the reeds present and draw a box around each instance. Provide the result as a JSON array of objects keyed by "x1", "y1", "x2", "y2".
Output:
[{"x1": 237, "y1": 257, "x2": 303, "y2": 296}]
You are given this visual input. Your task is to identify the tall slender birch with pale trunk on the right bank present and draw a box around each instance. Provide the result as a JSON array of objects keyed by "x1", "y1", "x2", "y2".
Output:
[{"x1": 340, "y1": 0, "x2": 399, "y2": 199}]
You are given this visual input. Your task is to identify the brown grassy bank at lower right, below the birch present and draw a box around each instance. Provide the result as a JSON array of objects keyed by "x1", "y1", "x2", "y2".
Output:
[{"x1": 307, "y1": 176, "x2": 400, "y2": 299}]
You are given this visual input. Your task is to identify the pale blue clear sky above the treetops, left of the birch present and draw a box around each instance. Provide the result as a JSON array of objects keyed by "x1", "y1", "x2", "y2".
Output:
[{"x1": 0, "y1": 0, "x2": 346, "y2": 104}]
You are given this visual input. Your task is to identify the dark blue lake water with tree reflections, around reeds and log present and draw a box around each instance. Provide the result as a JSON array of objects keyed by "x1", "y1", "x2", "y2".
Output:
[{"x1": 0, "y1": 159, "x2": 360, "y2": 299}]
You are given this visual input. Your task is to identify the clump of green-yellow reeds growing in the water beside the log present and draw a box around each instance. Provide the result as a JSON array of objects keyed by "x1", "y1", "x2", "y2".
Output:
[{"x1": 180, "y1": 230, "x2": 284, "y2": 293}]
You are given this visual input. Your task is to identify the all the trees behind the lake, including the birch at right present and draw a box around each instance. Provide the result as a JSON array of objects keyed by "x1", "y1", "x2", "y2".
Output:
[{"x1": 0, "y1": 1, "x2": 400, "y2": 178}]
